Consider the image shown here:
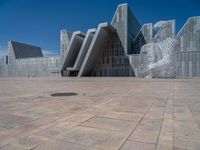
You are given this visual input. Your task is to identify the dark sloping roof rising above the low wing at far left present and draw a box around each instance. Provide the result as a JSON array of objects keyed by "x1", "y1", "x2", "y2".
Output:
[{"x1": 11, "y1": 41, "x2": 43, "y2": 59}]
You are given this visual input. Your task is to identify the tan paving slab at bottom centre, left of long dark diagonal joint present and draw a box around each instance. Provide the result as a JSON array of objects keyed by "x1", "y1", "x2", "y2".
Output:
[{"x1": 55, "y1": 126, "x2": 126, "y2": 149}]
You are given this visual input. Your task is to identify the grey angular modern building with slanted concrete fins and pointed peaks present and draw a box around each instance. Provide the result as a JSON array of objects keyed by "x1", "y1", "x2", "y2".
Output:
[{"x1": 0, "y1": 4, "x2": 200, "y2": 77}]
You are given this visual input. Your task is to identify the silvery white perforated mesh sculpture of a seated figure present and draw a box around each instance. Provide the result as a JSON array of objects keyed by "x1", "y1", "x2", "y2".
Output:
[{"x1": 139, "y1": 38, "x2": 177, "y2": 78}]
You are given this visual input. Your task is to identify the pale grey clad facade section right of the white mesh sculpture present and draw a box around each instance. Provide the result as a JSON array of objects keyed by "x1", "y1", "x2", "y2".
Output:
[{"x1": 176, "y1": 17, "x2": 200, "y2": 77}]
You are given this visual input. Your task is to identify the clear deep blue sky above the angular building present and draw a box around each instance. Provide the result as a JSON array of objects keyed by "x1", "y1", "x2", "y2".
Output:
[{"x1": 0, "y1": 0, "x2": 200, "y2": 56}]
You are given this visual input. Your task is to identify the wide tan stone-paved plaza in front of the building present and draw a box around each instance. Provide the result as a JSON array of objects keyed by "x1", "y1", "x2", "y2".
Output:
[{"x1": 0, "y1": 78, "x2": 200, "y2": 150}]
